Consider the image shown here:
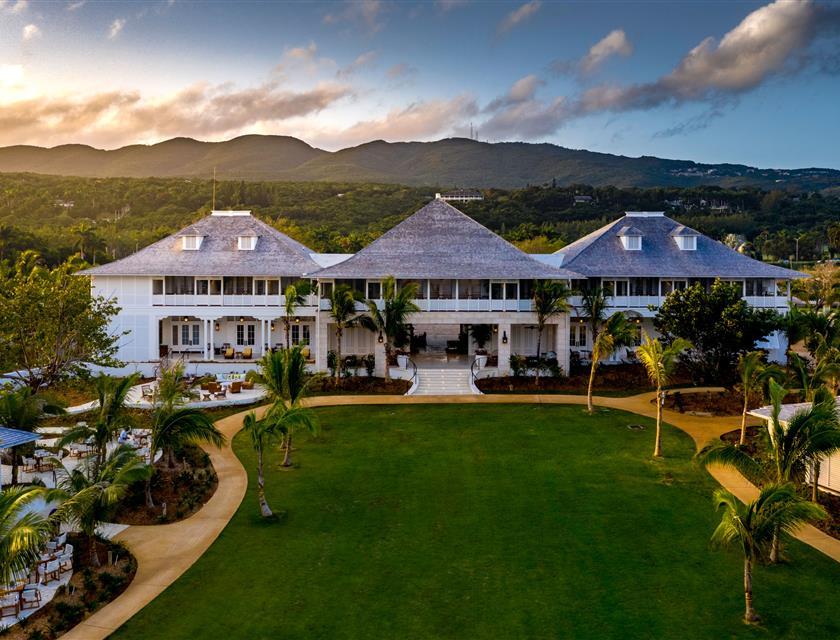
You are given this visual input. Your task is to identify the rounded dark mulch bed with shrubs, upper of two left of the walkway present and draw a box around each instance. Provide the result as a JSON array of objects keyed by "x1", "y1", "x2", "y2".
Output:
[{"x1": 112, "y1": 445, "x2": 219, "y2": 525}]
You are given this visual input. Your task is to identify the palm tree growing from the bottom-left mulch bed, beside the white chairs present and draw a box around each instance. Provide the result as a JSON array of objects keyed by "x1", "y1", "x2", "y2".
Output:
[{"x1": 47, "y1": 446, "x2": 151, "y2": 567}]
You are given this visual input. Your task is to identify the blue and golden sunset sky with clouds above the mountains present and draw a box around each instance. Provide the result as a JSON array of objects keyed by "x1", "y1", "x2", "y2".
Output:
[{"x1": 0, "y1": 0, "x2": 840, "y2": 168}]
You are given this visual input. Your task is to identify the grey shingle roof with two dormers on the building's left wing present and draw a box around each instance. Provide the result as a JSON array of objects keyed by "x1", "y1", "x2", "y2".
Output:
[{"x1": 81, "y1": 212, "x2": 320, "y2": 276}]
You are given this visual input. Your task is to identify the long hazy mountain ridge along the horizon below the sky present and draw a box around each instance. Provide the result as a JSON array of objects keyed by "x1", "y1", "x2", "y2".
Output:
[{"x1": 0, "y1": 135, "x2": 840, "y2": 191}]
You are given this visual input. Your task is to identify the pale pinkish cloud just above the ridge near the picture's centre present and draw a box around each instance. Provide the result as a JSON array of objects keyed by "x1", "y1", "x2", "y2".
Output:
[{"x1": 322, "y1": 95, "x2": 478, "y2": 145}]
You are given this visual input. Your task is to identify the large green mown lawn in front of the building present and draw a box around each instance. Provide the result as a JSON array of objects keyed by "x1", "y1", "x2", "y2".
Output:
[{"x1": 115, "y1": 405, "x2": 840, "y2": 640}]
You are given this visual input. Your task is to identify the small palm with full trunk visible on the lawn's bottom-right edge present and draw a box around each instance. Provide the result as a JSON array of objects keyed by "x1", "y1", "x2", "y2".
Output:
[{"x1": 712, "y1": 484, "x2": 825, "y2": 624}]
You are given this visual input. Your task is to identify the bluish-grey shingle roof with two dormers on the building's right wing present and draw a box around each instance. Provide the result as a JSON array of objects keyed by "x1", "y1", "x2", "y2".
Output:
[{"x1": 546, "y1": 213, "x2": 805, "y2": 279}]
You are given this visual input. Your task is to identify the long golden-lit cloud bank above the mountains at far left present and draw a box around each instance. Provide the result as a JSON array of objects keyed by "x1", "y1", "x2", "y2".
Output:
[{"x1": 0, "y1": 65, "x2": 352, "y2": 146}]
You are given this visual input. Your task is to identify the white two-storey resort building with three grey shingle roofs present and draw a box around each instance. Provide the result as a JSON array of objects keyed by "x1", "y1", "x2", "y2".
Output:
[{"x1": 82, "y1": 198, "x2": 800, "y2": 375}]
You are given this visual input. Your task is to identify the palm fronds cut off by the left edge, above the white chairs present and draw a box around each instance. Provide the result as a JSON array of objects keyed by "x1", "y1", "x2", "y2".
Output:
[{"x1": 0, "y1": 487, "x2": 52, "y2": 584}]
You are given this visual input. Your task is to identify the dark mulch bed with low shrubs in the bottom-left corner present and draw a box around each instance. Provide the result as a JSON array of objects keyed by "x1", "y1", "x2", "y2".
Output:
[{"x1": 3, "y1": 534, "x2": 137, "y2": 640}]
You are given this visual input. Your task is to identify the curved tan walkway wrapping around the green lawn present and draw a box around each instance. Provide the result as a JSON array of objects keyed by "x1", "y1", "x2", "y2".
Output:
[{"x1": 63, "y1": 387, "x2": 840, "y2": 640}]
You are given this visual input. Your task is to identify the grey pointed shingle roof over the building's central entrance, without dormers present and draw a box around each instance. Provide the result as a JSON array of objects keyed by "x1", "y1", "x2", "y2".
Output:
[{"x1": 314, "y1": 199, "x2": 580, "y2": 280}]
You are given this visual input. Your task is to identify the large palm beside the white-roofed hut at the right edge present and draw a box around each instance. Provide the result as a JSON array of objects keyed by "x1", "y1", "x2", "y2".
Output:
[{"x1": 697, "y1": 379, "x2": 840, "y2": 562}]
